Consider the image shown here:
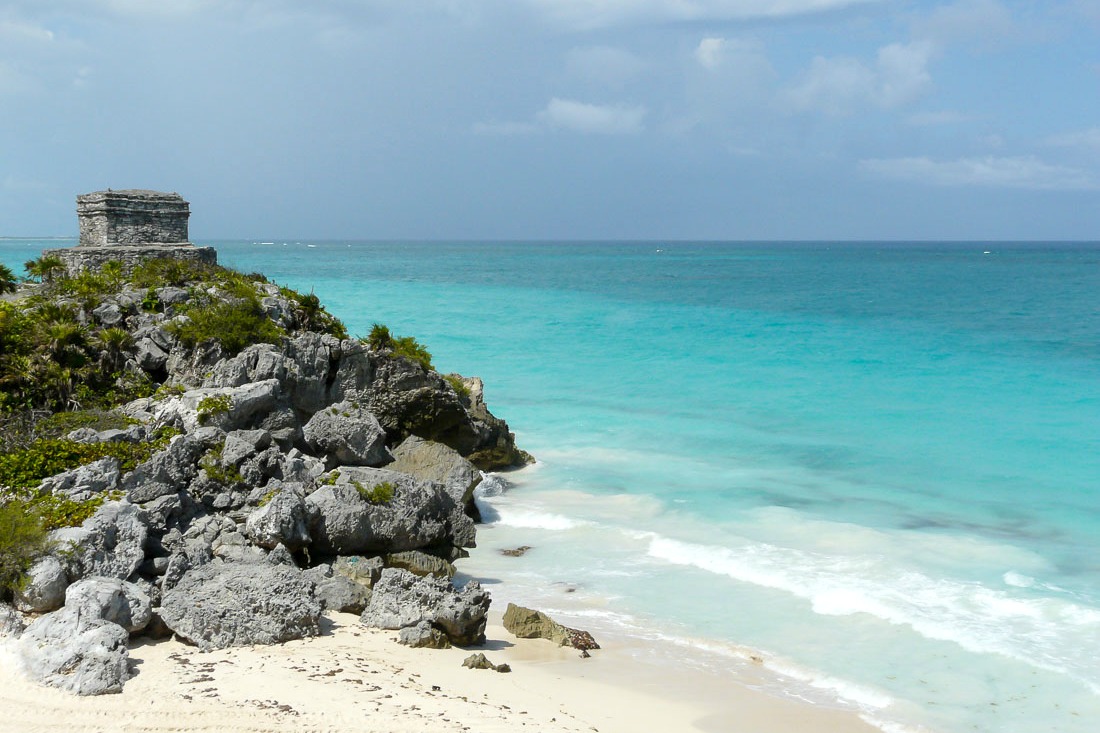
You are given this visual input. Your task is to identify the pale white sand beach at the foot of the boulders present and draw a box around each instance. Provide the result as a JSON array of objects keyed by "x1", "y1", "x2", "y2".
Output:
[{"x1": 0, "y1": 614, "x2": 873, "y2": 733}]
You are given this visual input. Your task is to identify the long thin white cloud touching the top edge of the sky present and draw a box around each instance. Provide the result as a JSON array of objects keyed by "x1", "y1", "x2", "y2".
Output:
[{"x1": 517, "y1": 0, "x2": 884, "y2": 29}]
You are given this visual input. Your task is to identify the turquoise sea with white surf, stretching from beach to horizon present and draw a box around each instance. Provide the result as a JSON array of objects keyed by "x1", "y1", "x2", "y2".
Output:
[{"x1": 0, "y1": 240, "x2": 1100, "y2": 733}]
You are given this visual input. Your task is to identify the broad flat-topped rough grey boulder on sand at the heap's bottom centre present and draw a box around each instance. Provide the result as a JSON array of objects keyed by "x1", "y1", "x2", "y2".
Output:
[{"x1": 158, "y1": 564, "x2": 321, "y2": 649}]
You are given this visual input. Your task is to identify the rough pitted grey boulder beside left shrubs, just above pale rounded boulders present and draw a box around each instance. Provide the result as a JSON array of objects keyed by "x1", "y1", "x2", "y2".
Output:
[{"x1": 50, "y1": 502, "x2": 149, "y2": 582}]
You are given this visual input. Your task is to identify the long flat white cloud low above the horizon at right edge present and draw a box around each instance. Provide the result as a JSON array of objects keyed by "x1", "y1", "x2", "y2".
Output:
[{"x1": 859, "y1": 156, "x2": 1097, "y2": 190}]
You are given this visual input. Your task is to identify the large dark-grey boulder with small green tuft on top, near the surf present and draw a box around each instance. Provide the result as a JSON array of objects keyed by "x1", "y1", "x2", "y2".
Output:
[{"x1": 306, "y1": 467, "x2": 474, "y2": 555}]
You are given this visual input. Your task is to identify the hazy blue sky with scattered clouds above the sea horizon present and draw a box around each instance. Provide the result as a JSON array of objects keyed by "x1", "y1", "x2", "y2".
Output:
[{"x1": 0, "y1": 0, "x2": 1100, "y2": 240}]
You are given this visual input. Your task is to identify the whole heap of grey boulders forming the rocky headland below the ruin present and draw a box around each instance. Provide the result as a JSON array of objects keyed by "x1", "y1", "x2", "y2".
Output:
[{"x1": 0, "y1": 254, "x2": 527, "y2": 694}]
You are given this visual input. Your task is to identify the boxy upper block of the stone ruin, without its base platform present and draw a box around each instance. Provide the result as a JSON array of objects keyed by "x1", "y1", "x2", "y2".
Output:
[{"x1": 76, "y1": 189, "x2": 190, "y2": 247}]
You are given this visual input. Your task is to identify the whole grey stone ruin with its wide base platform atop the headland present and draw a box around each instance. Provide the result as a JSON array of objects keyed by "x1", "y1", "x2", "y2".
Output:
[{"x1": 43, "y1": 188, "x2": 218, "y2": 275}]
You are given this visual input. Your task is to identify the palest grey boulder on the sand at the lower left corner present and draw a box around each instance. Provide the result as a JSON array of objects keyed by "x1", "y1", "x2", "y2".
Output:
[{"x1": 18, "y1": 606, "x2": 130, "y2": 694}]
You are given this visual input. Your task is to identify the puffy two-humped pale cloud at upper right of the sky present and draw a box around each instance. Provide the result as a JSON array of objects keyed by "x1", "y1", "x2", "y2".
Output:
[{"x1": 785, "y1": 42, "x2": 934, "y2": 116}]
